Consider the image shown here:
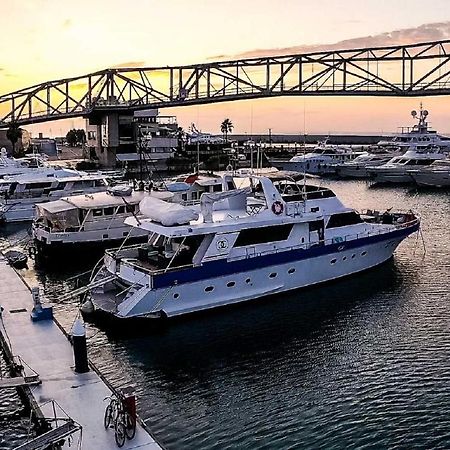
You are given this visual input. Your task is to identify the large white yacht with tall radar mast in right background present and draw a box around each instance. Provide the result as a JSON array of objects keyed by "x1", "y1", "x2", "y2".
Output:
[{"x1": 377, "y1": 103, "x2": 450, "y2": 151}]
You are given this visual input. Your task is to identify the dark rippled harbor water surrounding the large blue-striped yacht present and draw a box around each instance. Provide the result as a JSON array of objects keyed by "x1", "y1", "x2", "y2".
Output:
[{"x1": 0, "y1": 181, "x2": 450, "y2": 449}]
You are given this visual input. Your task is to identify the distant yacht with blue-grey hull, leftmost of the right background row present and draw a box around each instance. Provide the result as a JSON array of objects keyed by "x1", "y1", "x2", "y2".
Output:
[{"x1": 270, "y1": 140, "x2": 362, "y2": 175}]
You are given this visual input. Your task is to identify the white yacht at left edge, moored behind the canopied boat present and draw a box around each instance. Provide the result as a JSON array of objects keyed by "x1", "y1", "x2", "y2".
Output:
[{"x1": 0, "y1": 169, "x2": 109, "y2": 222}]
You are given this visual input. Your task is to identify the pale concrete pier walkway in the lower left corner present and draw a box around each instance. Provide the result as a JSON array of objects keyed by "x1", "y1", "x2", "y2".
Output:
[{"x1": 0, "y1": 255, "x2": 161, "y2": 450}]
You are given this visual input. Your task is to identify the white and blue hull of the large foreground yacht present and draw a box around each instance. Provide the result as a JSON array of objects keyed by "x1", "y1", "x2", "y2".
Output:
[{"x1": 91, "y1": 225, "x2": 418, "y2": 318}]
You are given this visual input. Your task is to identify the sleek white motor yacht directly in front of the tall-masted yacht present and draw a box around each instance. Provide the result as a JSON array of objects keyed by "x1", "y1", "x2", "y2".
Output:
[{"x1": 367, "y1": 146, "x2": 446, "y2": 183}]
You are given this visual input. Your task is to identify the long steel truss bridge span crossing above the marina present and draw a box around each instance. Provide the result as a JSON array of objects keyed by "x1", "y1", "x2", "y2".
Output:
[{"x1": 0, "y1": 40, "x2": 450, "y2": 127}]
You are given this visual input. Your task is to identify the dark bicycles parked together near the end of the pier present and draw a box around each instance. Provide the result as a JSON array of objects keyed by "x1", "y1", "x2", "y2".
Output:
[{"x1": 103, "y1": 395, "x2": 136, "y2": 447}]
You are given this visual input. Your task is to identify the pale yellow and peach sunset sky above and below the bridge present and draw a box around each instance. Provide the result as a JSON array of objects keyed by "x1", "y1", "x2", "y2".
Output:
[{"x1": 0, "y1": 0, "x2": 450, "y2": 136}]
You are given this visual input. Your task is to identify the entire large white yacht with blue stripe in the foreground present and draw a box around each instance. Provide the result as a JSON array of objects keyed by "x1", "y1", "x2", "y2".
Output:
[{"x1": 85, "y1": 173, "x2": 419, "y2": 319}]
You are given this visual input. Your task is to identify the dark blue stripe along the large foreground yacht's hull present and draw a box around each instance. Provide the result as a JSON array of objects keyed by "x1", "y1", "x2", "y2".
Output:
[{"x1": 153, "y1": 224, "x2": 419, "y2": 289}]
